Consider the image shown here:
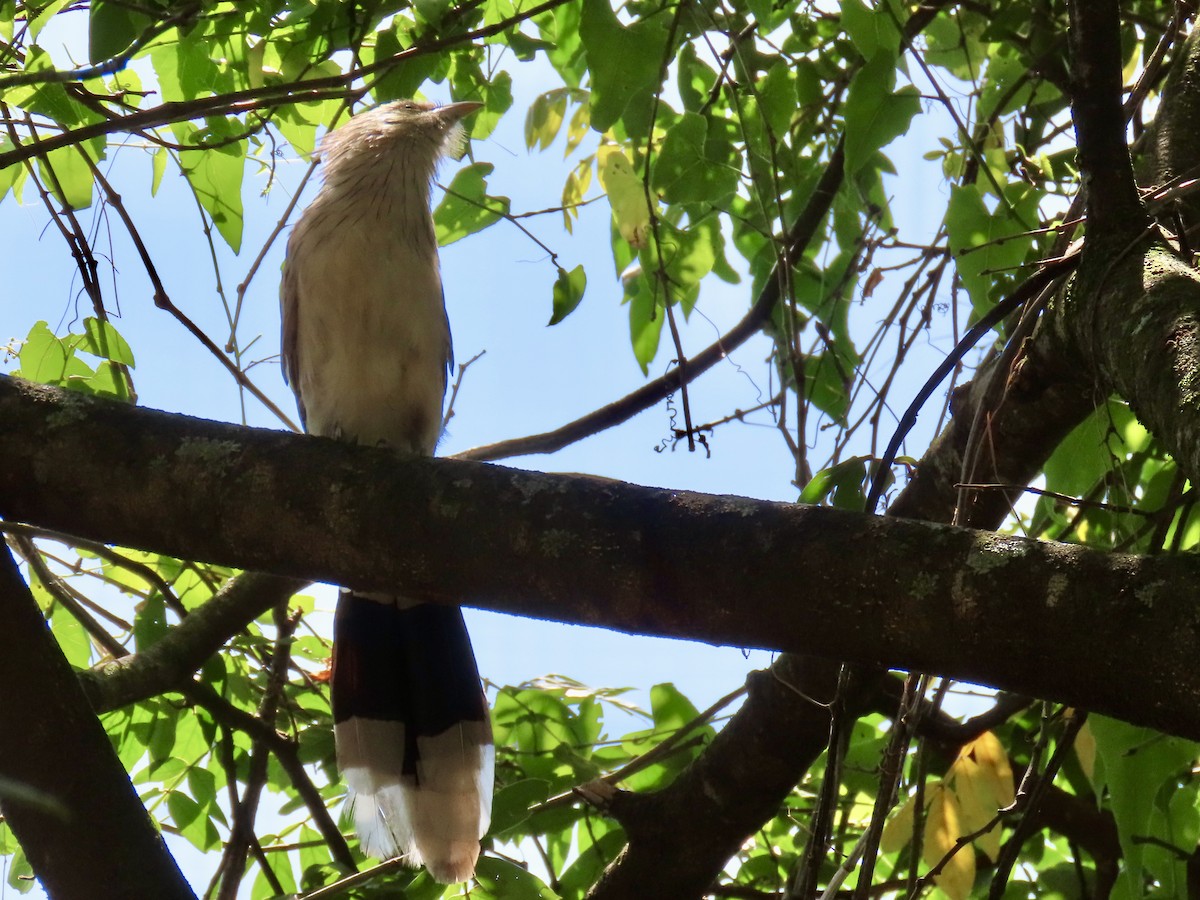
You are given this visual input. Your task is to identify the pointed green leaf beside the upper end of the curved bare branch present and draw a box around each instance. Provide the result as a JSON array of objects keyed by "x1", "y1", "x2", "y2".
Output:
[{"x1": 845, "y1": 54, "x2": 920, "y2": 178}]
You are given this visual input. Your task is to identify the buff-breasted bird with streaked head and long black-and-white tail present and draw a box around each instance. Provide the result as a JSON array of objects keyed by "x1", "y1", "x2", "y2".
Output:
[{"x1": 280, "y1": 101, "x2": 493, "y2": 883}]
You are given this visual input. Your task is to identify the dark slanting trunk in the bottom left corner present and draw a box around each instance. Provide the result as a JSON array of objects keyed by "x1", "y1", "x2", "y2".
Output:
[{"x1": 0, "y1": 542, "x2": 194, "y2": 900}]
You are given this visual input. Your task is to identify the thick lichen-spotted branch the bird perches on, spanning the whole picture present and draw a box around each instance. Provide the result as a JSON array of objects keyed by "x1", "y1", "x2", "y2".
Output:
[{"x1": 0, "y1": 378, "x2": 1200, "y2": 737}]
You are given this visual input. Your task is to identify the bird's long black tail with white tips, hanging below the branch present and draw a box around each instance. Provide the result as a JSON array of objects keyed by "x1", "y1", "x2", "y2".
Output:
[{"x1": 332, "y1": 590, "x2": 493, "y2": 883}]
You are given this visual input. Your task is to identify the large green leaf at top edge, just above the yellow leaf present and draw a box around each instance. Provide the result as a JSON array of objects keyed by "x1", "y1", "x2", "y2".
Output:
[{"x1": 580, "y1": 0, "x2": 667, "y2": 137}]
